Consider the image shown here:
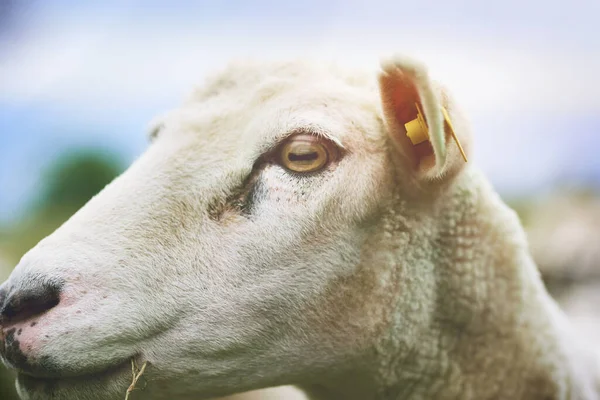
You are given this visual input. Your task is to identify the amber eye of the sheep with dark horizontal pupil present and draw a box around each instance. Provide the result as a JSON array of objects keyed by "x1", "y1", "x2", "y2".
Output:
[{"x1": 280, "y1": 135, "x2": 330, "y2": 172}]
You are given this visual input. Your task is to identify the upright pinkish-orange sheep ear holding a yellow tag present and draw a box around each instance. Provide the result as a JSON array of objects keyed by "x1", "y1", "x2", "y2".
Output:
[{"x1": 379, "y1": 57, "x2": 468, "y2": 179}]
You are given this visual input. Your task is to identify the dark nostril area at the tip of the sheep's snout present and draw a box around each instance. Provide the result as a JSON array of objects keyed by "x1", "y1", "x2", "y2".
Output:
[{"x1": 0, "y1": 282, "x2": 61, "y2": 325}]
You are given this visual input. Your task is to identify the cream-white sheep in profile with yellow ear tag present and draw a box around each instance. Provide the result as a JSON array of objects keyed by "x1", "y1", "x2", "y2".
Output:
[{"x1": 0, "y1": 56, "x2": 600, "y2": 400}]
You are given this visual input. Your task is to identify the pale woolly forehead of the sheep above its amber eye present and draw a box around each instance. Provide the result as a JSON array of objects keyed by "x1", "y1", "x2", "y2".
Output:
[{"x1": 156, "y1": 62, "x2": 381, "y2": 159}]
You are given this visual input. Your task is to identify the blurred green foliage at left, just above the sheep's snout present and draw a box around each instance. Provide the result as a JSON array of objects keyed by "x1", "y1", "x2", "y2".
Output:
[{"x1": 0, "y1": 149, "x2": 124, "y2": 400}]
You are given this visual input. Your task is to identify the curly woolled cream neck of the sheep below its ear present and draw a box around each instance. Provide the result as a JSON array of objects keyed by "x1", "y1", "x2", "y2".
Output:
[{"x1": 304, "y1": 173, "x2": 595, "y2": 400}]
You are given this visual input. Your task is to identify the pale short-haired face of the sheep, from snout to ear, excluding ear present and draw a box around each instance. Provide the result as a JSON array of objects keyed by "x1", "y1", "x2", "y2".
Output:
[{"x1": 0, "y1": 59, "x2": 468, "y2": 399}]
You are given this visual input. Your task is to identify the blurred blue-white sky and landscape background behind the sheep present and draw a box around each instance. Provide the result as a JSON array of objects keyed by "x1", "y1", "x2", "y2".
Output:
[{"x1": 0, "y1": 0, "x2": 600, "y2": 400}]
